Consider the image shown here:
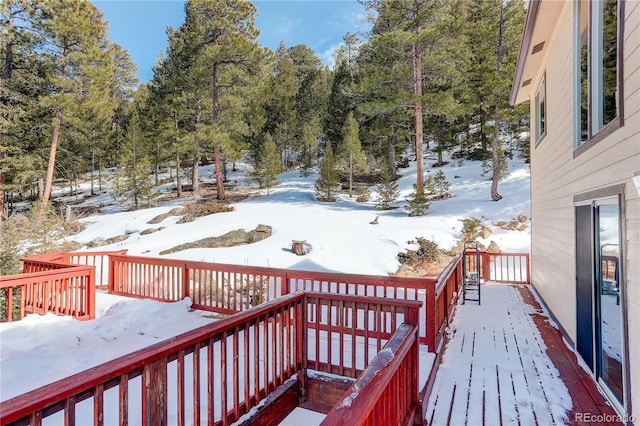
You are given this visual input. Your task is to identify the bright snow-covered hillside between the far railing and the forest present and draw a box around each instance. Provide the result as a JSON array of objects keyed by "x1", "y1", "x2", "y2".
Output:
[{"x1": 71, "y1": 151, "x2": 530, "y2": 275}]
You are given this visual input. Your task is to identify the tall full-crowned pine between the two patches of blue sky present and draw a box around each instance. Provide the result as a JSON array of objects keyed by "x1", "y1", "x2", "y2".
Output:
[{"x1": 169, "y1": 0, "x2": 266, "y2": 200}]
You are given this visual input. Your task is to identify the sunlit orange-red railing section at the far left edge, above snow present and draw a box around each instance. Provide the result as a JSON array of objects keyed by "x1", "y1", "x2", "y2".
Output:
[{"x1": 0, "y1": 266, "x2": 96, "y2": 322}]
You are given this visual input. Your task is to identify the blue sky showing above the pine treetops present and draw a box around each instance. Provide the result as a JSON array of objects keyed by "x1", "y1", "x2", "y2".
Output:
[{"x1": 93, "y1": 0, "x2": 370, "y2": 82}]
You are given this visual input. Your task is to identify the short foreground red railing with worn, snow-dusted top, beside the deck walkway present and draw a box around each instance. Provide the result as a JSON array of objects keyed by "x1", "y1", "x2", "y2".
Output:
[{"x1": 321, "y1": 324, "x2": 423, "y2": 426}]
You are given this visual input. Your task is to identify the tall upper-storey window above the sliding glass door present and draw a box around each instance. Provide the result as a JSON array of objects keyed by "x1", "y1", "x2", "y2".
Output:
[{"x1": 574, "y1": 0, "x2": 623, "y2": 148}]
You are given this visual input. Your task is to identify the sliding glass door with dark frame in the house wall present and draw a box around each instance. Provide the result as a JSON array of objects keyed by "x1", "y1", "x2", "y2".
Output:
[{"x1": 575, "y1": 197, "x2": 626, "y2": 411}]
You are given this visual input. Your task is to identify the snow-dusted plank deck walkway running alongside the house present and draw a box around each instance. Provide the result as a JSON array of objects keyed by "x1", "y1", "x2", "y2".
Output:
[{"x1": 426, "y1": 284, "x2": 616, "y2": 425}]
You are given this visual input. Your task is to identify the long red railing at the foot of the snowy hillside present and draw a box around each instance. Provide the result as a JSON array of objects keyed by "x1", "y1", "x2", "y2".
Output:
[{"x1": 109, "y1": 255, "x2": 436, "y2": 350}]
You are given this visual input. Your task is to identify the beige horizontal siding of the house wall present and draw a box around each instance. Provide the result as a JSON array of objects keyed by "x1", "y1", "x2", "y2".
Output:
[{"x1": 530, "y1": 1, "x2": 640, "y2": 422}]
